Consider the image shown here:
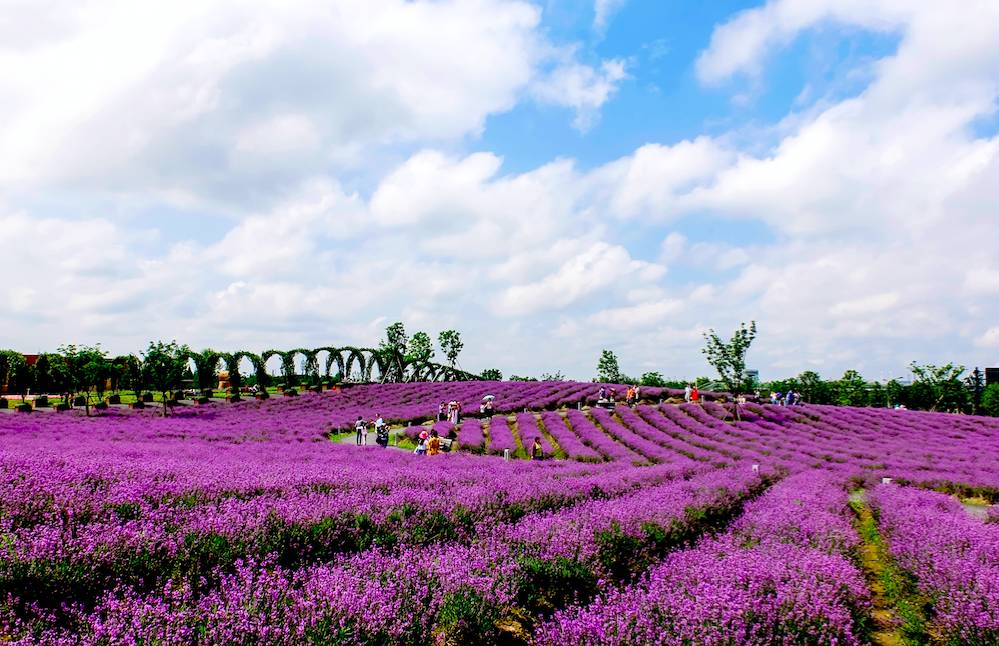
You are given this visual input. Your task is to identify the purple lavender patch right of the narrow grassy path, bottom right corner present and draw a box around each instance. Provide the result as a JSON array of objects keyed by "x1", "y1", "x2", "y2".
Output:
[{"x1": 868, "y1": 484, "x2": 999, "y2": 644}]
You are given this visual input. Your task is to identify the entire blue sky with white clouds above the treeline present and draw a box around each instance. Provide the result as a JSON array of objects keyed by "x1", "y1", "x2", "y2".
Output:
[{"x1": 0, "y1": 0, "x2": 999, "y2": 379}]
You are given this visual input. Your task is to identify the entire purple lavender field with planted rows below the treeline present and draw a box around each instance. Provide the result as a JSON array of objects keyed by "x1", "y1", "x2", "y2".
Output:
[{"x1": 0, "y1": 382, "x2": 999, "y2": 644}]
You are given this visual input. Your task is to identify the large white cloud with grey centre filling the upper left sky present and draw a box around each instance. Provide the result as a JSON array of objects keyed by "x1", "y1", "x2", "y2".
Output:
[{"x1": 0, "y1": 0, "x2": 624, "y2": 197}]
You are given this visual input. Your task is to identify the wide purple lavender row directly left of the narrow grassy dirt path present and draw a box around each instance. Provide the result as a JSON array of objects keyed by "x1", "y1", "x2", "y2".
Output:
[{"x1": 536, "y1": 472, "x2": 870, "y2": 646}]
